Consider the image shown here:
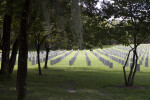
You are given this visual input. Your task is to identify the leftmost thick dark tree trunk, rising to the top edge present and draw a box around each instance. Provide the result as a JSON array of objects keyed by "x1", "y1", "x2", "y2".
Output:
[{"x1": 1, "y1": 0, "x2": 13, "y2": 76}]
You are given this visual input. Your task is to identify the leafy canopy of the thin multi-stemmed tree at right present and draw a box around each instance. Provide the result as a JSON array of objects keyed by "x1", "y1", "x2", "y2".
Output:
[{"x1": 104, "y1": 0, "x2": 150, "y2": 45}]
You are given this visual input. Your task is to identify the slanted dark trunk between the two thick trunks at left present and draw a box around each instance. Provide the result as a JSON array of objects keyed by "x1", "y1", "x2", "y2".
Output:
[{"x1": 9, "y1": 38, "x2": 19, "y2": 74}]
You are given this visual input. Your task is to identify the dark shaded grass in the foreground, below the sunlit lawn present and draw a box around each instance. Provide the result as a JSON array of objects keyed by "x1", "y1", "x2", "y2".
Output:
[{"x1": 0, "y1": 68, "x2": 150, "y2": 100}]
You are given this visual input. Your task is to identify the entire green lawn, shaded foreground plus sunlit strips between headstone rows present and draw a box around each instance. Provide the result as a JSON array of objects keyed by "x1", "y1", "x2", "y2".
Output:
[{"x1": 0, "y1": 50, "x2": 150, "y2": 100}]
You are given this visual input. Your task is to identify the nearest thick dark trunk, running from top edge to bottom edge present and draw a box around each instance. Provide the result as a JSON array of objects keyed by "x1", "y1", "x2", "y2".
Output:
[{"x1": 17, "y1": 0, "x2": 30, "y2": 100}]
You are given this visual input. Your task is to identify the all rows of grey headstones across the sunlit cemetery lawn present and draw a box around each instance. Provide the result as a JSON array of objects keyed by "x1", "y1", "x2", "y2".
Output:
[{"x1": 0, "y1": 44, "x2": 150, "y2": 71}]
